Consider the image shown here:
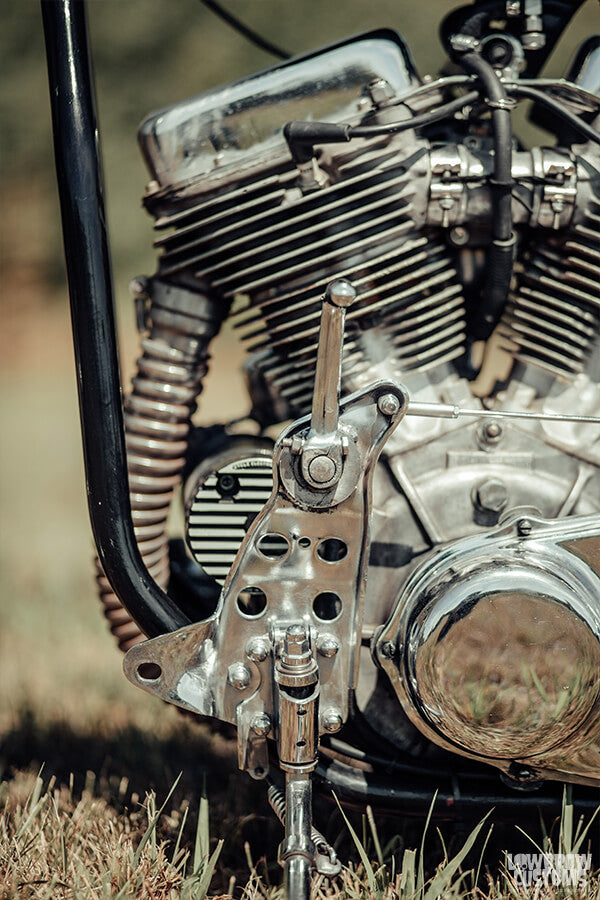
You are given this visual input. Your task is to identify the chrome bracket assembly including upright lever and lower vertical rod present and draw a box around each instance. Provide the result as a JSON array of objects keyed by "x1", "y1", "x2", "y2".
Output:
[{"x1": 124, "y1": 281, "x2": 408, "y2": 900}]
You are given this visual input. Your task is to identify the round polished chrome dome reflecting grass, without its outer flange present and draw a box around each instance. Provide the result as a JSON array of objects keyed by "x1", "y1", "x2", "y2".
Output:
[{"x1": 400, "y1": 546, "x2": 600, "y2": 759}]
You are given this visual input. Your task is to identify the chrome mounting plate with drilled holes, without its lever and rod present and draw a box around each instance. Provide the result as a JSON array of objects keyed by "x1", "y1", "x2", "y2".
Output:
[{"x1": 125, "y1": 382, "x2": 406, "y2": 743}]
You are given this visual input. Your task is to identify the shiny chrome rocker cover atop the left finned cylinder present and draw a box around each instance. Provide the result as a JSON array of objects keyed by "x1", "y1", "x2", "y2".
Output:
[{"x1": 140, "y1": 30, "x2": 417, "y2": 188}]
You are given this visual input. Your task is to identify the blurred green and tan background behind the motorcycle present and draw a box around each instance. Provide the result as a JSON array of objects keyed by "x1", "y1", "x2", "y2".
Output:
[{"x1": 0, "y1": 0, "x2": 600, "y2": 744}]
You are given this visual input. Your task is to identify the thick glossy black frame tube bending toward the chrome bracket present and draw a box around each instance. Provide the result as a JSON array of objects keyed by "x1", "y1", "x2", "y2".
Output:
[{"x1": 42, "y1": 0, "x2": 189, "y2": 637}]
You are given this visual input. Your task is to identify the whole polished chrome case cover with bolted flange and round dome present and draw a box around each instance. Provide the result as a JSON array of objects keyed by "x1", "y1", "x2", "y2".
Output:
[{"x1": 375, "y1": 515, "x2": 600, "y2": 783}]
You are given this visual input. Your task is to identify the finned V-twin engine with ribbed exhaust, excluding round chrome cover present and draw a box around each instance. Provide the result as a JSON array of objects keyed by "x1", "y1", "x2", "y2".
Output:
[{"x1": 104, "y1": 31, "x2": 600, "y2": 788}]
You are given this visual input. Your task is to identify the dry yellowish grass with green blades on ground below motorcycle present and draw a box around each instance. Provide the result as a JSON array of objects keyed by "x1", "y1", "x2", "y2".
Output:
[{"x1": 0, "y1": 773, "x2": 600, "y2": 900}]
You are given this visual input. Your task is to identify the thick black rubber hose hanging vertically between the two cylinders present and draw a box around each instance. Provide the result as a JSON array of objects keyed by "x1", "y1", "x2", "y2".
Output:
[{"x1": 458, "y1": 51, "x2": 516, "y2": 340}]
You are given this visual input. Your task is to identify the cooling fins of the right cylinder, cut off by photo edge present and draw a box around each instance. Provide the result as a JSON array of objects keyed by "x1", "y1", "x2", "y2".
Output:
[{"x1": 500, "y1": 201, "x2": 600, "y2": 380}]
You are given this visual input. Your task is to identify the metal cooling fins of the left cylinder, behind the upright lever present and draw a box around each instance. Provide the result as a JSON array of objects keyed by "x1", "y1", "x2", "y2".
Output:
[{"x1": 156, "y1": 138, "x2": 465, "y2": 420}]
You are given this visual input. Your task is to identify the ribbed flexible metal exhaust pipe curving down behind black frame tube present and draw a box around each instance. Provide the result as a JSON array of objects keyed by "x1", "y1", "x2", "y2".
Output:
[{"x1": 97, "y1": 290, "x2": 217, "y2": 652}]
